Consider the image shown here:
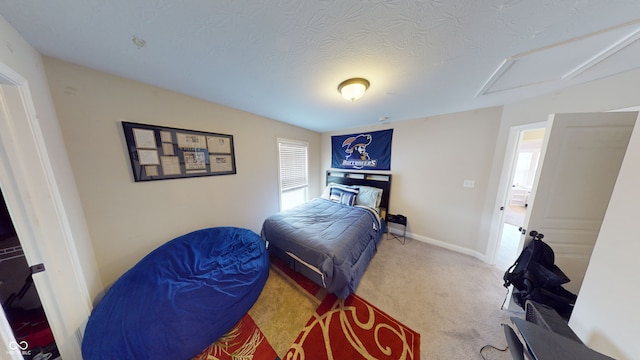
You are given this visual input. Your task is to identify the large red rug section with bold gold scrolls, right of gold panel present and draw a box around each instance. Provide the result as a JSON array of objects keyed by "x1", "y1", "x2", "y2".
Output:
[{"x1": 283, "y1": 294, "x2": 420, "y2": 360}]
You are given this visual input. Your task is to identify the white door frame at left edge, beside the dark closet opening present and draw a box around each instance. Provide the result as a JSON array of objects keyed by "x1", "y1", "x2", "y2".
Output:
[{"x1": 0, "y1": 62, "x2": 91, "y2": 359}]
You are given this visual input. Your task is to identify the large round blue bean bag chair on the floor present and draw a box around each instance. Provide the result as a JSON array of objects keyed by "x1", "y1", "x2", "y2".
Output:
[{"x1": 82, "y1": 227, "x2": 269, "y2": 360}]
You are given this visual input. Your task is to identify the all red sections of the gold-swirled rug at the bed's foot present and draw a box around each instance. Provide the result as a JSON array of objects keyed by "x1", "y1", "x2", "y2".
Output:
[{"x1": 193, "y1": 257, "x2": 420, "y2": 360}]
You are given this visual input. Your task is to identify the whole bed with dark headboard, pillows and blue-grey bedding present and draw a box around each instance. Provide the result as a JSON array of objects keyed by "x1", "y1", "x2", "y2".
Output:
[{"x1": 261, "y1": 170, "x2": 391, "y2": 299}]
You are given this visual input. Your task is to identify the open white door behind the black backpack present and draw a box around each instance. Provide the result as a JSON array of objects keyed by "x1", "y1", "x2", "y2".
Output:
[{"x1": 523, "y1": 112, "x2": 638, "y2": 294}]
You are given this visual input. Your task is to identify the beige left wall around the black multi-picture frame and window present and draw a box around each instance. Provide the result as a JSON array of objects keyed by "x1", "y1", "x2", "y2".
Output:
[{"x1": 45, "y1": 58, "x2": 320, "y2": 285}]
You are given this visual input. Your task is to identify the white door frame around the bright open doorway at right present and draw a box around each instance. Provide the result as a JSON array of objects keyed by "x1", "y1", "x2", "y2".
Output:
[{"x1": 487, "y1": 121, "x2": 548, "y2": 265}]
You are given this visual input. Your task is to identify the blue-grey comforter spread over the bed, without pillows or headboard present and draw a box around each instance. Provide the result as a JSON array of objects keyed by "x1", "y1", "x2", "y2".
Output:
[{"x1": 262, "y1": 198, "x2": 382, "y2": 298}]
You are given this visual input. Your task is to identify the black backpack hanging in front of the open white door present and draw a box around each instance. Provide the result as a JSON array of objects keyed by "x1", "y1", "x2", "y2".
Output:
[{"x1": 502, "y1": 231, "x2": 576, "y2": 319}]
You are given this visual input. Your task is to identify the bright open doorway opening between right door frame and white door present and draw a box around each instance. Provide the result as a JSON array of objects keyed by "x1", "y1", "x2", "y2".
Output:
[{"x1": 495, "y1": 125, "x2": 545, "y2": 271}]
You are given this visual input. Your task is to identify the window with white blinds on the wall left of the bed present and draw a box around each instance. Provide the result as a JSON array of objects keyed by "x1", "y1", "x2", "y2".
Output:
[{"x1": 278, "y1": 139, "x2": 309, "y2": 210}]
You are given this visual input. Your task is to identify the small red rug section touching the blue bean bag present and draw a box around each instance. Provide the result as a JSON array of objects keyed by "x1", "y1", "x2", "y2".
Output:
[{"x1": 193, "y1": 314, "x2": 279, "y2": 360}]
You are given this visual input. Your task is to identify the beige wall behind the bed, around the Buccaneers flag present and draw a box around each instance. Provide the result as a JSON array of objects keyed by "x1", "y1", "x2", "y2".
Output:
[{"x1": 321, "y1": 107, "x2": 501, "y2": 259}]
